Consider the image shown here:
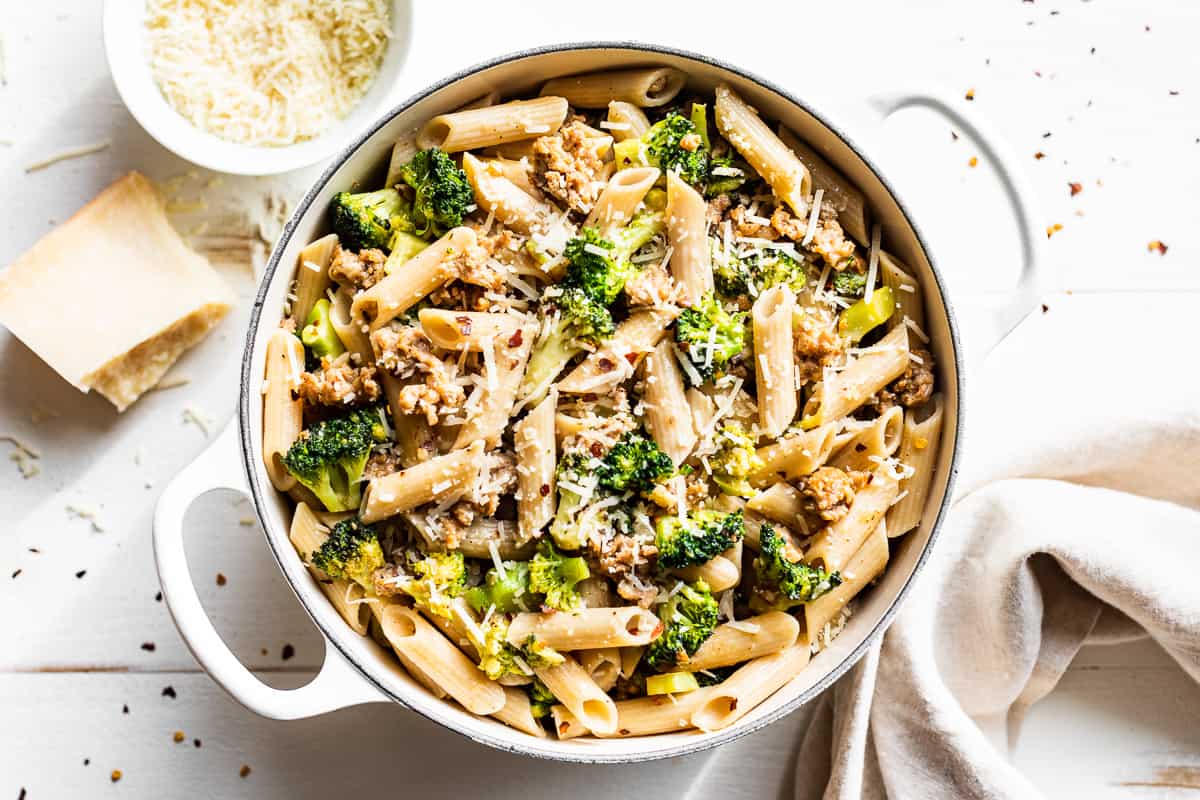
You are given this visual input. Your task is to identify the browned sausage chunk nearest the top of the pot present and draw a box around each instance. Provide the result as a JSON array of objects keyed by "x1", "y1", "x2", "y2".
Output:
[{"x1": 533, "y1": 121, "x2": 605, "y2": 213}]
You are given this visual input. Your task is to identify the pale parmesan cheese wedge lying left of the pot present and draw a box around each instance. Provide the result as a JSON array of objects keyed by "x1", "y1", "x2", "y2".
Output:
[{"x1": 0, "y1": 173, "x2": 234, "y2": 411}]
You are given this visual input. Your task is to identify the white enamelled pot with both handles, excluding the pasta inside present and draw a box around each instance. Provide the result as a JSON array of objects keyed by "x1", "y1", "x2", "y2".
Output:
[{"x1": 155, "y1": 43, "x2": 1042, "y2": 763}]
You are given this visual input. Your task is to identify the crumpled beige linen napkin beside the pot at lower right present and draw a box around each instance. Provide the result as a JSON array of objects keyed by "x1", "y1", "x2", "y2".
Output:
[{"x1": 796, "y1": 295, "x2": 1200, "y2": 800}]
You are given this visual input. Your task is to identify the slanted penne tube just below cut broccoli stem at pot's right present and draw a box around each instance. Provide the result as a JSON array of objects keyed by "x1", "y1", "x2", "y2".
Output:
[{"x1": 800, "y1": 326, "x2": 908, "y2": 429}]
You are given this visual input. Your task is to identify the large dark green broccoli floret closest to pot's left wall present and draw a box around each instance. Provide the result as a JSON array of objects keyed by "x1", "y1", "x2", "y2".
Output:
[{"x1": 283, "y1": 408, "x2": 388, "y2": 511}]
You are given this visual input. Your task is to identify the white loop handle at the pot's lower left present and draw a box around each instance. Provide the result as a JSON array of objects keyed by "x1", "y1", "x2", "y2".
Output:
[{"x1": 154, "y1": 421, "x2": 389, "y2": 720}]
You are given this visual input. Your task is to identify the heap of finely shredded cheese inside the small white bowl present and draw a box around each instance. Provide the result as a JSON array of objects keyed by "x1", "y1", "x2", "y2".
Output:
[{"x1": 145, "y1": 0, "x2": 391, "y2": 146}]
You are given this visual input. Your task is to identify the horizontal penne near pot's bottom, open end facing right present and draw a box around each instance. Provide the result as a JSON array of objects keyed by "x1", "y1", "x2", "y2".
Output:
[{"x1": 509, "y1": 606, "x2": 662, "y2": 650}]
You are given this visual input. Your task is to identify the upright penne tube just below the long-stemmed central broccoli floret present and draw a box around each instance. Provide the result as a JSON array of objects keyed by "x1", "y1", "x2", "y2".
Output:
[{"x1": 512, "y1": 389, "x2": 558, "y2": 540}]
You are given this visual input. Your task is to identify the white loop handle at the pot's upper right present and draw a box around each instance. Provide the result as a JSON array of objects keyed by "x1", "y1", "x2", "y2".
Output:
[{"x1": 866, "y1": 89, "x2": 1046, "y2": 361}]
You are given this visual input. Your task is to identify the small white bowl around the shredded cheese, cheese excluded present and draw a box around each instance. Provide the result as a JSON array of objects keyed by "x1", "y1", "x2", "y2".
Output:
[{"x1": 104, "y1": 0, "x2": 413, "y2": 175}]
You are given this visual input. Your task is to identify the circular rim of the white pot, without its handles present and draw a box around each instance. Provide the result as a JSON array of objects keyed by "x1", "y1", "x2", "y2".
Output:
[{"x1": 238, "y1": 40, "x2": 964, "y2": 764}]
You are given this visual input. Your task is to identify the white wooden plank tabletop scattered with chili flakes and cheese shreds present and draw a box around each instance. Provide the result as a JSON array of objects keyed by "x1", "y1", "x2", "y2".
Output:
[{"x1": 0, "y1": 0, "x2": 1200, "y2": 800}]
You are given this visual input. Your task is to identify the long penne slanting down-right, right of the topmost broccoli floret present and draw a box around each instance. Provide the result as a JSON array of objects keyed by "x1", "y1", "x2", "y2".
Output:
[{"x1": 713, "y1": 84, "x2": 812, "y2": 217}]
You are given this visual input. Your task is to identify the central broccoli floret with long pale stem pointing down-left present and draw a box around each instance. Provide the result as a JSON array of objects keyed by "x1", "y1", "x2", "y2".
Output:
[{"x1": 521, "y1": 287, "x2": 616, "y2": 403}]
